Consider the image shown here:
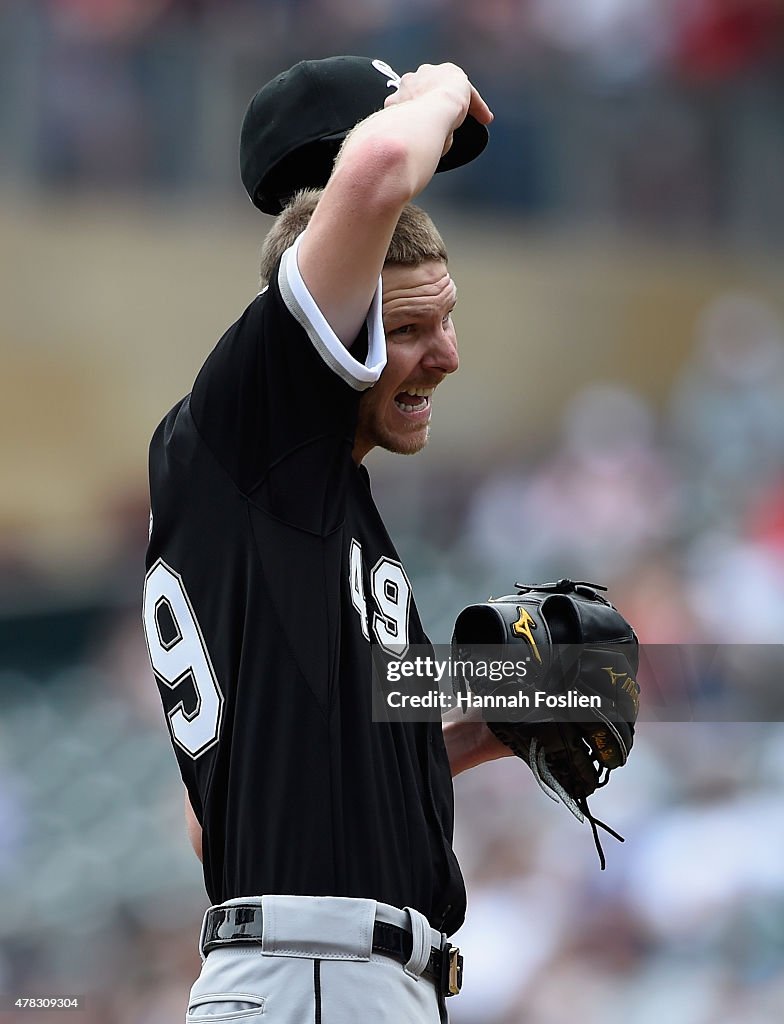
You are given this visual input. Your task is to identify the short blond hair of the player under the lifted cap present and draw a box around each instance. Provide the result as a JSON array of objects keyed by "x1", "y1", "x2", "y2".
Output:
[{"x1": 261, "y1": 188, "x2": 447, "y2": 288}]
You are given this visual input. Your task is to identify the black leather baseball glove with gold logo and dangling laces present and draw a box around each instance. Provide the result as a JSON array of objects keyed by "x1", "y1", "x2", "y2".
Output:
[{"x1": 452, "y1": 580, "x2": 640, "y2": 868}]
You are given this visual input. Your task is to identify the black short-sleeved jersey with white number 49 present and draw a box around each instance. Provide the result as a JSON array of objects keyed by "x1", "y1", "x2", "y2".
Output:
[{"x1": 144, "y1": 237, "x2": 465, "y2": 934}]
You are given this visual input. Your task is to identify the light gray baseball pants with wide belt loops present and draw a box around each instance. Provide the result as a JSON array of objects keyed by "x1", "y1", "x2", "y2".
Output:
[{"x1": 185, "y1": 896, "x2": 446, "y2": 1024}]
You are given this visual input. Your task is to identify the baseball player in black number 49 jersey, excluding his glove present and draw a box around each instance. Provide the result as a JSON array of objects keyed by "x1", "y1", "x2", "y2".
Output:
[{"x1": 143, "y1": 57, "x2": 499, "y2": 1024}]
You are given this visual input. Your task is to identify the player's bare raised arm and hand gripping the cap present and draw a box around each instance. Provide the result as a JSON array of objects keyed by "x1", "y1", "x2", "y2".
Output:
[{"x1": 298, "y1": 63, "x2": 492, "y2": 346}]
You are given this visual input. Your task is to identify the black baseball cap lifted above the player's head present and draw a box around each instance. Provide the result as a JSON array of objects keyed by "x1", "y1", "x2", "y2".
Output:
[{"x1": 239, "y1": 56, "x2": 488, "y2": 214}]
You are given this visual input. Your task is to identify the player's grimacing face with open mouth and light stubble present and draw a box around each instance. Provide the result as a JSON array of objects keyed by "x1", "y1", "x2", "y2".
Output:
[{"x1": 353, "y1": 260, "x2": 459, "y2": 463}]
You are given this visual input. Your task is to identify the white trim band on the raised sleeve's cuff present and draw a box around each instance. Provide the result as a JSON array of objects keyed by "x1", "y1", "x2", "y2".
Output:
[{"x1": 277, "y1": 234, "x2": 387, "y2": 391}]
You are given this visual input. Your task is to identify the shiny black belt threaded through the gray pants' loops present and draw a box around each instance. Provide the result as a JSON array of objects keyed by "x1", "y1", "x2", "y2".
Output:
[{"x1": 202, "y1": 903, "x2": 463, "y2": 995}]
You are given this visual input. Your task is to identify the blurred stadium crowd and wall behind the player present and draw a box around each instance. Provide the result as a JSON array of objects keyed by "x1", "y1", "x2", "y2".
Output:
[{"x1": 0, "y1": 0, "x2": 784, "y2": 1024}]
